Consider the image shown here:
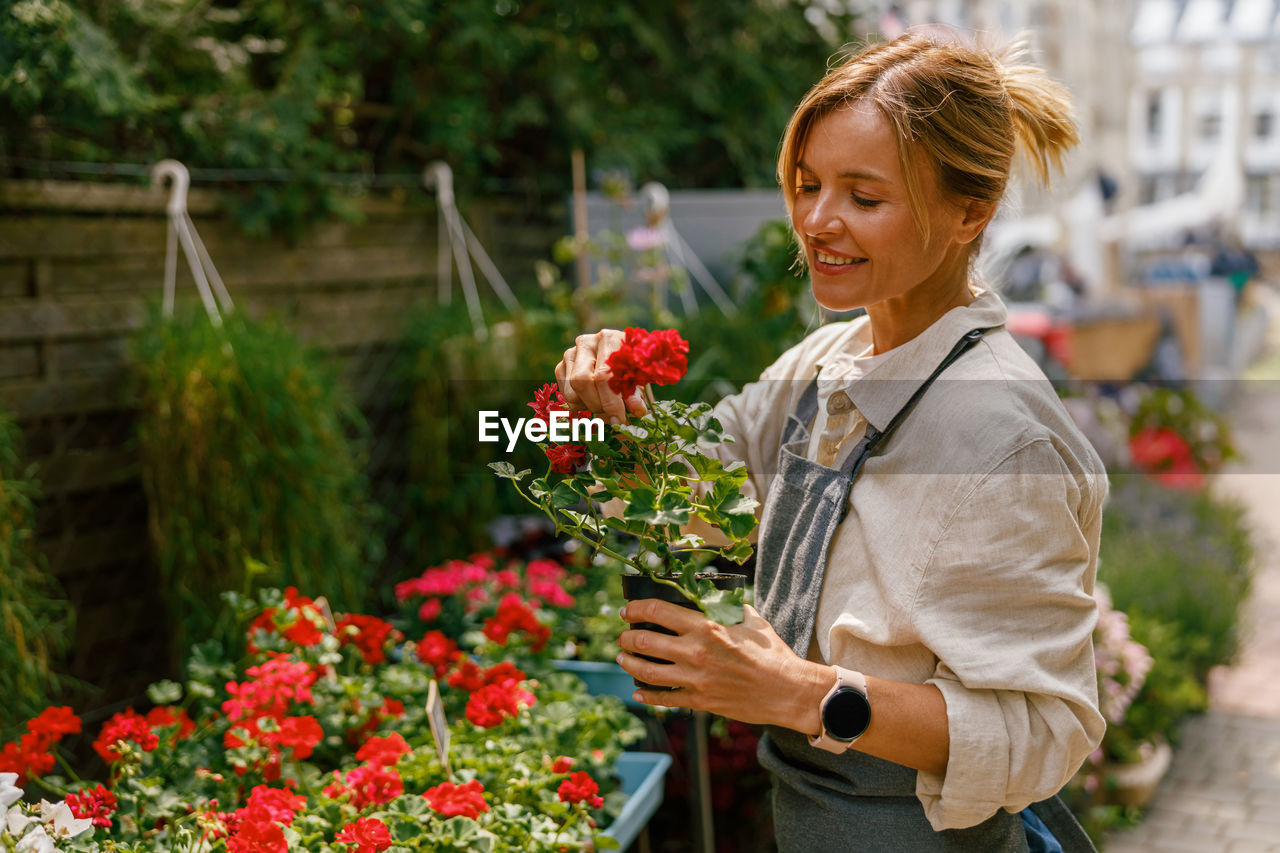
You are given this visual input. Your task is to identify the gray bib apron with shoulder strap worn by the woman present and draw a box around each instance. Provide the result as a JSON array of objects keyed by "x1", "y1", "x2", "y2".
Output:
[{"x1": 755, "y1": 329, "x2": 1096, "y2": 853}]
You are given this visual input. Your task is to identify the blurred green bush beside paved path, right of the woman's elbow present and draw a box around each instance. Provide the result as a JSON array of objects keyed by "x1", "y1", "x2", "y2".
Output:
[{"x1": 1098, "y1": 476, "x2": 1253, "y2": 681}]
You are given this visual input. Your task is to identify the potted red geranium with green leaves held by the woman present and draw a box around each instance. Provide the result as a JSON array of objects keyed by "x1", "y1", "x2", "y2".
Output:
[{"x1": 490, "y1": 328, "x2": 758, "y2": 625}]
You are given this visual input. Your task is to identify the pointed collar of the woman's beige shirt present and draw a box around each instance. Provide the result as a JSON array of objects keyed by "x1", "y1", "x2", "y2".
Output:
[{"x1": 819, "y1": 291, "x2": 1007, "y2": 429}]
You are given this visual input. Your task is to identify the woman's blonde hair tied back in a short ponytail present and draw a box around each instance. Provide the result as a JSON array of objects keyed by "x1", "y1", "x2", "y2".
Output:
[{"x1": 778, "y1": 32, "x2": 1079, "y2": 250}]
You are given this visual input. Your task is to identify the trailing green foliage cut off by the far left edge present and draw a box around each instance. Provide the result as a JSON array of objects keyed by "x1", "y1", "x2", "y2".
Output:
[{"x1": 0, "y1": 412, "x2": 74, "y2": 733}]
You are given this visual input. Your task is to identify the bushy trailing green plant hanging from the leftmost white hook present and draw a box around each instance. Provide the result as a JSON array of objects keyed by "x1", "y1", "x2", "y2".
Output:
[{"x1": 133, "y1": 305, "x2": 380, "y2": 653}]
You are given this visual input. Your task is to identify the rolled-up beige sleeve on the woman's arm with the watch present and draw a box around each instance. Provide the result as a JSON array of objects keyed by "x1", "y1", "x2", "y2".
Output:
[{"x1": 913, "y1": 439, "x2": 1106, "y2": 830}]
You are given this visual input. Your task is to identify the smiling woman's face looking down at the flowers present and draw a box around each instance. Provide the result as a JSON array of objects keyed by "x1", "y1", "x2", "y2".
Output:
[{"x1": 791, "y1": 104, "x2": 968, "y2": 311}]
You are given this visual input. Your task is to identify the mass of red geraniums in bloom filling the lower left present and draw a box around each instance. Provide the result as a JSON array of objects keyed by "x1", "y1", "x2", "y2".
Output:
[{"x1": 0, "y1": 564, "x2": 641, "y2": 853}]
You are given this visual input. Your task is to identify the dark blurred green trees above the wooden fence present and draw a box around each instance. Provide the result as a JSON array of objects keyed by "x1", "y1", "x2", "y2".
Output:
[{"x1": 0, "y1": 0, "x2": 861, "y2": 231}]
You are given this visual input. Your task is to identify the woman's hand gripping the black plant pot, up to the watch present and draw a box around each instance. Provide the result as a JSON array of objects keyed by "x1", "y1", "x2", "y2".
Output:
[{"x1": 618, "y1": 598, "x2": 833, "y2": 734}]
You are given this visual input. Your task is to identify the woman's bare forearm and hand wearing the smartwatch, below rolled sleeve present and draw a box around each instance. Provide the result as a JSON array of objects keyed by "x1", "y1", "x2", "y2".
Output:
[{"x1": 618, "y1": 598, "x2": 950, "y2": 774}]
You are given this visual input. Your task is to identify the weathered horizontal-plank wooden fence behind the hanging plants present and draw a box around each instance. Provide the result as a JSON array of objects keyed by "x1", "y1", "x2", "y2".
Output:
[{"x1": 0, "y1": 175, "x2": 564, "y2": 702}]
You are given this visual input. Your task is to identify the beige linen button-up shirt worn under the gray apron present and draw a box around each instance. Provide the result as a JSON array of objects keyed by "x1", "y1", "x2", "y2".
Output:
[{"x1": 716, "y1": 292, "x2": 1107, "y2": 830}]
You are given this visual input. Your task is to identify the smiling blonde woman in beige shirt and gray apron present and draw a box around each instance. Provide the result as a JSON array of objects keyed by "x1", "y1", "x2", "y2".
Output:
[{"x1": 557, "y1": 33, "x2": 1106, "y2": 852}]
